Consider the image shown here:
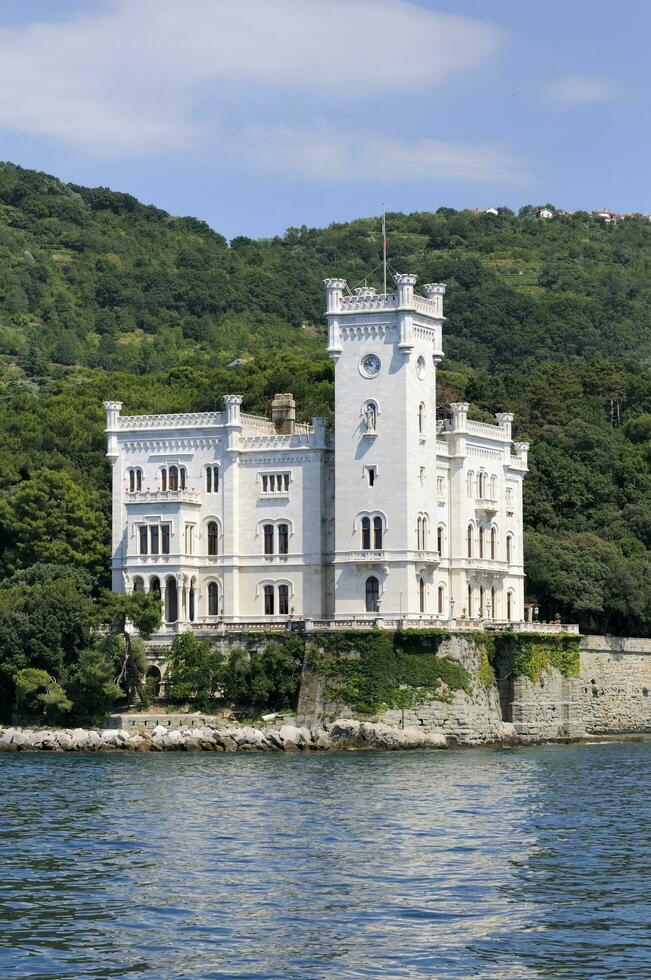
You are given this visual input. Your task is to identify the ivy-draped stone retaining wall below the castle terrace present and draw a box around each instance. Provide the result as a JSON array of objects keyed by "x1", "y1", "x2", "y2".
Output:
[{"x1": 149, "y1": 629, "x2": 651, "y2": 744}]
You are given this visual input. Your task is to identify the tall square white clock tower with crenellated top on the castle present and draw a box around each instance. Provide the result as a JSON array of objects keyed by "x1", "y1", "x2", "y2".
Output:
[{"x1": 325, "y1": 275, "x2": 445, "y2": 618}]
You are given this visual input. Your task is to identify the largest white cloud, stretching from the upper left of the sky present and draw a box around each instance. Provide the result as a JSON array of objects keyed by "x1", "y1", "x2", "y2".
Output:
[{"x1": 0, "y1": 0, "x2": 503, "y2": 156}]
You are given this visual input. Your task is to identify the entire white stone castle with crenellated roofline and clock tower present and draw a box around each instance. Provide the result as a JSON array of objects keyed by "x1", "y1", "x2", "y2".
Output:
[{"x1": 104, "y1": 275, "x2": 529, "y2": 633}]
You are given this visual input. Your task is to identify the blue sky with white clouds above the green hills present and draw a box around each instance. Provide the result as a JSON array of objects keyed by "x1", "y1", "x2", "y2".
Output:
[{"x1": 0, "y1": 0, "x2": 651, "y2": 238}]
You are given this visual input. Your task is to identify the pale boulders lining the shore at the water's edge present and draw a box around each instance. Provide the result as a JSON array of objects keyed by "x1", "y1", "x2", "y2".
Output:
[{"x1": 0, "y1": 719, "x2": 448, "y2": 752}]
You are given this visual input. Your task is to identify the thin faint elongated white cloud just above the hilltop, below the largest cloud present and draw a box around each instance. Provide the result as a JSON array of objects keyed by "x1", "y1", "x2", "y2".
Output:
[{"x1": 237, "y1": 123, "x2": 527, "y2": 182}]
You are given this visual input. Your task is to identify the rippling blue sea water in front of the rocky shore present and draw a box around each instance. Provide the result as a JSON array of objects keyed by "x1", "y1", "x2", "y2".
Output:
[{"x1": 0, "y1": 744, "x2": 651, "y2": 978}]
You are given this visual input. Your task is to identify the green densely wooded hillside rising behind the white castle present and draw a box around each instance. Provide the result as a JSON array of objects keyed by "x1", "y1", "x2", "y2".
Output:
[{"x1": 0, "y1": 164, "x2": 651, "y2": 640}]
